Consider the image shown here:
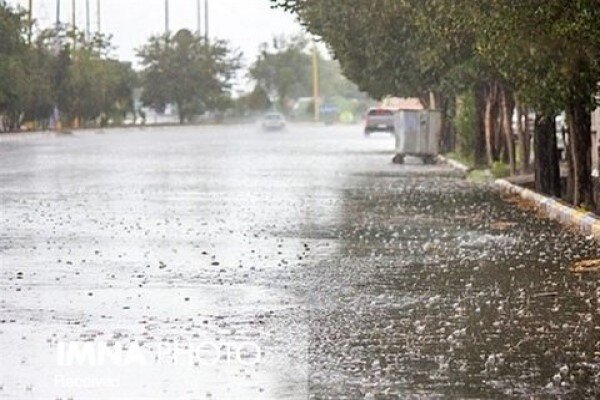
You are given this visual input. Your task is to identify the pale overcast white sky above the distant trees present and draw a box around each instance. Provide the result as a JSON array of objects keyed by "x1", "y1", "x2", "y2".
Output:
[{"x1": 9, "y1": 0, "x2": 302, "y2": 65}]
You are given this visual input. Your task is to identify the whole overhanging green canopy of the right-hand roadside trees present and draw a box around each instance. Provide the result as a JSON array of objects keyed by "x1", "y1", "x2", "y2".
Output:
[{"x1": 272, "y1": 0, "x2": 600, "y2": 113}]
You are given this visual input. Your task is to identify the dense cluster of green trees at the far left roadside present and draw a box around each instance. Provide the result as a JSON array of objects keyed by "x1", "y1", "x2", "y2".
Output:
[{"x1": 0, "y1": 2, "x2": 136, "y2": 131}]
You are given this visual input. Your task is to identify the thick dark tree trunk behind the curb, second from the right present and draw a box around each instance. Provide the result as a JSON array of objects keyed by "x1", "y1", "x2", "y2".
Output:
[{"x1": 533, "y1": 115, "x2": 561, "y2": 197}]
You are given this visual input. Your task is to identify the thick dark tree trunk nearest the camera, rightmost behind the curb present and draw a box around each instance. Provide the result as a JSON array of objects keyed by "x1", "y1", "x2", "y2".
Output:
[{"x1": 567, "y1": 101, "x2": 595, "y2": 210}]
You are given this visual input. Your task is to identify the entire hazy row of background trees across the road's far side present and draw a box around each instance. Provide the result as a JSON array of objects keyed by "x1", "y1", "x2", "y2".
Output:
[{"x1": 0, "y1": 0, "x2": 360, "y2": 131}]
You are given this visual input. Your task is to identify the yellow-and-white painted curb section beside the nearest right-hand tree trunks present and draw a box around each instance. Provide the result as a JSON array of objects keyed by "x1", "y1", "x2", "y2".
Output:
[{"x1": 494, "y1": 179, "x2": 600, "y2": 240}]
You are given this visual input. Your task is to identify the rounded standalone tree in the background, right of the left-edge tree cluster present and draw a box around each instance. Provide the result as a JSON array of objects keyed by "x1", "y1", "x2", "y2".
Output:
[{"x1": 138, "y1": 30, "x2": 241, "y2": 123}]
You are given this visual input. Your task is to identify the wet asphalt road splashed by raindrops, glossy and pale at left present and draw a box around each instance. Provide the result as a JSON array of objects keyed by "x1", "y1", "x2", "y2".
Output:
[{"x1": 0, "y1": 126, "x2": 600, "y2": 399}]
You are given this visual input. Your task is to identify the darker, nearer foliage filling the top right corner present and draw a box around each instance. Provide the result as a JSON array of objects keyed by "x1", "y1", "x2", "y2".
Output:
[{"x1": 473, "y1": 0, "x2": 600, "y2": 115}]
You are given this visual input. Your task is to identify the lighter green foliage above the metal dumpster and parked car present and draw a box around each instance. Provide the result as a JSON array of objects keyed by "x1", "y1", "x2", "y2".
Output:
[{"x1": 273, "y1": 0, "x2": 473, "y2": 98}]
